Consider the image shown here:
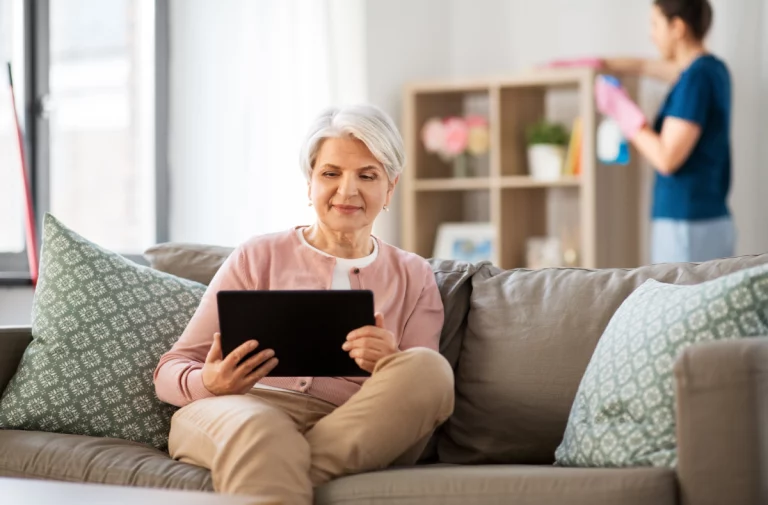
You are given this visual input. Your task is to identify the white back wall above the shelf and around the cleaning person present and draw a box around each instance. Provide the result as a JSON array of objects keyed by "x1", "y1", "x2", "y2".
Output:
[{"x1": 452, "y1": 0, "x2": 768, "y2": 254}]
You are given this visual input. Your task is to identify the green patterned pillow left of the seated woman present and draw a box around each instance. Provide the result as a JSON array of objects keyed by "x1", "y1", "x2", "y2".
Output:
[{"x1": 0, "y1": 215, "x2": 205, "y2": 449}]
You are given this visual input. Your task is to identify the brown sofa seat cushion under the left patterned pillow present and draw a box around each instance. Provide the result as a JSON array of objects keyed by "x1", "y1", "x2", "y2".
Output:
[{"x1": 0, "y1": 430, "x2": 213, "y2": 490}]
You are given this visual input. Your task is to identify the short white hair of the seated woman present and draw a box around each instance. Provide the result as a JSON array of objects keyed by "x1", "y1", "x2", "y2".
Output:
[{"x1": 300, "y1": 105, "x2": 405, "y2": 182}]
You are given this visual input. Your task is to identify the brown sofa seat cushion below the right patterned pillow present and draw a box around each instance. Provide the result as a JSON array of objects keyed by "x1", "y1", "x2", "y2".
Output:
[{"x1": 315, "y1": 465, "x2": 677, "y2": 505}]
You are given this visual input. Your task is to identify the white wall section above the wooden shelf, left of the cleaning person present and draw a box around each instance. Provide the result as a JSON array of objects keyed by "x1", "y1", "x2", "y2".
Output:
[{"x1": 452, "y1": 0, "x2": 650, "y2": 75}]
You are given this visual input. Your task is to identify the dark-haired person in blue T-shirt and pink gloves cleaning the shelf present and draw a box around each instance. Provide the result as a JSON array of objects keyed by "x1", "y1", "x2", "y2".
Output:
[{"x1": 560, "y1": 0, "x2": 736, "y2": 263}]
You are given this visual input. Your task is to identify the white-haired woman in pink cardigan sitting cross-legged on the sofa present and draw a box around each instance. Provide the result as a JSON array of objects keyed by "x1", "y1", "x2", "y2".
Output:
[{"x1": 154, "y1": 106, "x2": 453, "y2": 505}]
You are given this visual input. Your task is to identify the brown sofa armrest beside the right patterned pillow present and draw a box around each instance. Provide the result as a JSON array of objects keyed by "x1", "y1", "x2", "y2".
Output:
[{"x1": 675, "y1": 337, "x2": 768, "y2": 505}]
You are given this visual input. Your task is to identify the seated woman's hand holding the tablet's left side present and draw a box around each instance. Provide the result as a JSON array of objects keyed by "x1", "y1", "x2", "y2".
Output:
[{"x1": 203, "y1": 333, "x2": 277, "y2": 396}]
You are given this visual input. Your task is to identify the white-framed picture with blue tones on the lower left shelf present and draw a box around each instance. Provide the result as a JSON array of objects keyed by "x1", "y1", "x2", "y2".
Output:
[{"x1": 433, "y1": 223, "x2": 496, "y2": 263}]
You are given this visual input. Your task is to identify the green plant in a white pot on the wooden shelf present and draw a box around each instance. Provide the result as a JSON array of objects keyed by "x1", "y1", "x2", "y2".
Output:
[{"x1": 525, "y1": 120, "x2": 568, "y2": 180}]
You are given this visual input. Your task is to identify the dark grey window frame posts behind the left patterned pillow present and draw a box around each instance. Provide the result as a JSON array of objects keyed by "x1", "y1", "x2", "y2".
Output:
[{"x1": 0, "y1": 0, "x2": 170, "y2": 286}]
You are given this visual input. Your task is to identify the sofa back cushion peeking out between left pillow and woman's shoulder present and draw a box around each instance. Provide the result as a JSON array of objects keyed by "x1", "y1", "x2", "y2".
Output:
[{"x1": 144, "y1": 242, "x2": 234, "y2": 286}]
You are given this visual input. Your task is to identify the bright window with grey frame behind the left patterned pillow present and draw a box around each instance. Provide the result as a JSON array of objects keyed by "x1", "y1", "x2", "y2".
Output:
[{"x1": 0, "y1": 0, "x2": 168, "y2": 280}]
